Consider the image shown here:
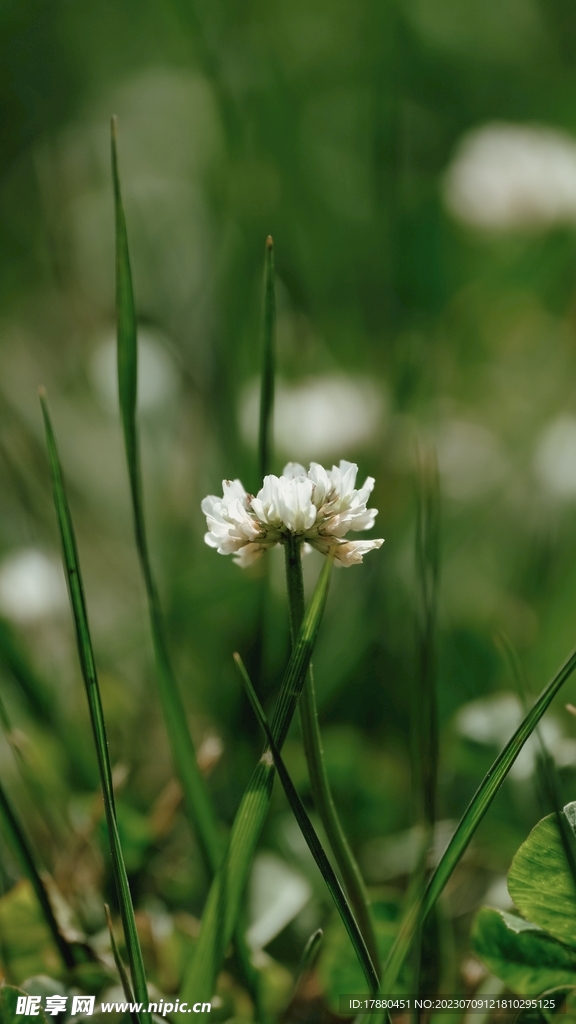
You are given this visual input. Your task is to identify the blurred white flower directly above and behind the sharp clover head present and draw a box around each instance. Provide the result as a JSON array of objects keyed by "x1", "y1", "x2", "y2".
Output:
[{"x1": 240, "y1": 376, "x2": 384, "y2": 459}]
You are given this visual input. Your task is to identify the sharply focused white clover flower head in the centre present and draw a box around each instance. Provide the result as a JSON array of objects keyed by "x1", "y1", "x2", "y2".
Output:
[{"x1": 202, "y1": 460, "x2": 384, "y2": 567}]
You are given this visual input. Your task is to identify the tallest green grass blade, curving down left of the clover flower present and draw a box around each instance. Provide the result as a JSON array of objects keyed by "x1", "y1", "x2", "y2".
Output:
[{"x1": 112, "y1": 112, "x2": 220, "y2": 877}]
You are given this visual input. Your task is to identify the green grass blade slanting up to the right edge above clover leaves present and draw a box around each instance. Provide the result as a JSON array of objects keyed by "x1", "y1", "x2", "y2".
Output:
[{"x1": 380, "y1": 650, "x2": 576, "y2": 994}]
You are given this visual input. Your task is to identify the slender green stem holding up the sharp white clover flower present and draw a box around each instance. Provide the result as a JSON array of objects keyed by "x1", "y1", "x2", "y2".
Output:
[{"x1": 284, "y1": 534, "x2": 380, "y2": 966}]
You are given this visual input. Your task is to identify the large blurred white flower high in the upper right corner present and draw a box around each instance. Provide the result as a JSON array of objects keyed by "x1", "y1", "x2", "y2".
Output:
[{"x1": 443, "y1": 122, "x2": 576, "y2": 230}]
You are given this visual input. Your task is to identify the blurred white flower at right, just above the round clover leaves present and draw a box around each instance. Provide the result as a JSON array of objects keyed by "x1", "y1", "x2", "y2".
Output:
[{"x1": 455, "y1": 693, "x2": 566, "y2": 779}]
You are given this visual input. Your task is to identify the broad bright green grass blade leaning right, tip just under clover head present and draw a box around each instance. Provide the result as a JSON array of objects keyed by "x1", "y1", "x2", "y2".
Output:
[{"x1": 181, "y1": 558, "x2": 332, "y2": 1001}]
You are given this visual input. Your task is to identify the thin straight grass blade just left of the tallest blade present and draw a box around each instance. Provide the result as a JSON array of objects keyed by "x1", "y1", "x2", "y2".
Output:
[{"x1": 40, "y1": 389, "x2": 152, "y2": 1024}]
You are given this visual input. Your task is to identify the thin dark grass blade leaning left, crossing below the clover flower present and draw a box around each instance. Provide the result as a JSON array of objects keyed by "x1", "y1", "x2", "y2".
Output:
[{"x1": 234, "y1": 654, "x2": 378, "y2": 994}]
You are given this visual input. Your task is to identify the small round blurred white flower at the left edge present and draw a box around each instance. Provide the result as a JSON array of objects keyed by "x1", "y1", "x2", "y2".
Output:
[{"x1": 0, "y1": 548, "x2": 67, "y2": 623}]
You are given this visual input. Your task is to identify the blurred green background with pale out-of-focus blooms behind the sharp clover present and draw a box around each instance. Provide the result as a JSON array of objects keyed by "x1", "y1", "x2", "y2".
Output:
[{"x1": 0, "y1": 0, "x2": 576, "y2": 1007}]
